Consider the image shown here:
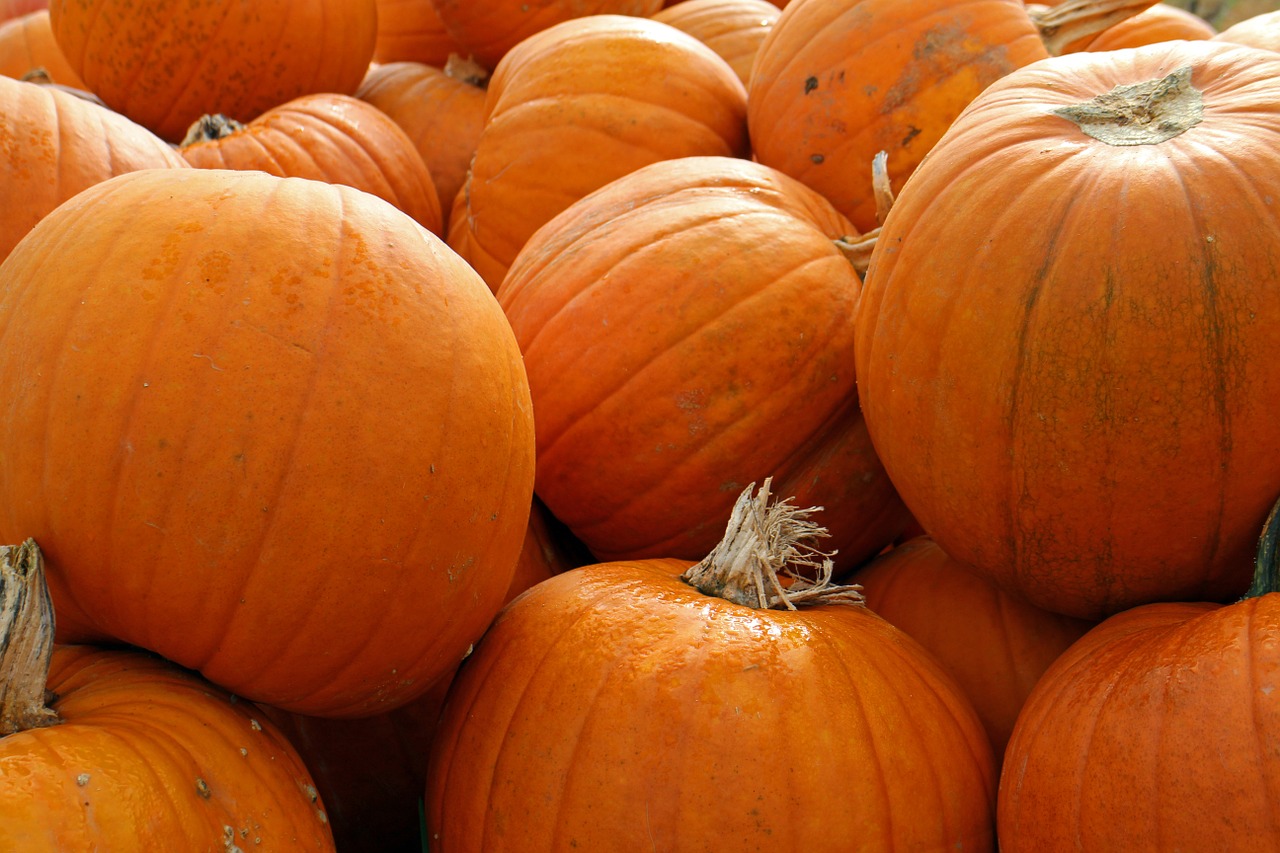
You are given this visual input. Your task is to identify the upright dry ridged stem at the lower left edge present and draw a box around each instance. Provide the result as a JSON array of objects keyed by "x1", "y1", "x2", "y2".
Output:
[{"x1": 0, "y1": 539, "x2": 58, "y2": 736}]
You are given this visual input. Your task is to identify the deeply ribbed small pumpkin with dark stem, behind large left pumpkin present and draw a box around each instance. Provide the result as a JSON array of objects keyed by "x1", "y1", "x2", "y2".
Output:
[{"x1": 179, "y1": 93, "x2": 444, "y2": 234}]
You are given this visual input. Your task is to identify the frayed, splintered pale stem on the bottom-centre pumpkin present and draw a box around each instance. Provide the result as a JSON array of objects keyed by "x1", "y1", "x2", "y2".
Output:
[{"x1": 681, "y1": 478, "x2": 863, "y2": 610}]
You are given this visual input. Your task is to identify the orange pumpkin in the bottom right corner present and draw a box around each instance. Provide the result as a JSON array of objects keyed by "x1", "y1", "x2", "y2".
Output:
[{"x1": 998, "y1": 593, "x2": 1280, "y2": 853}]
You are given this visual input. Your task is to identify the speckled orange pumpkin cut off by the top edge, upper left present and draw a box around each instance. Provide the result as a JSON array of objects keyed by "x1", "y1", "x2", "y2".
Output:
[{"x1": 49, "y1": 0, "x2": 378, "y2": 142}]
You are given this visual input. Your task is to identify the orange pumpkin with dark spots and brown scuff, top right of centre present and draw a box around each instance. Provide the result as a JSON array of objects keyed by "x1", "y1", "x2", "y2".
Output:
[{"x1": 748, "y1": 0, "x2": 1048, "y2": 231}]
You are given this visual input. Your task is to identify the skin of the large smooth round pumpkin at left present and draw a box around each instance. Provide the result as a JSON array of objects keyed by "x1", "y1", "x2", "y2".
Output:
[{"x1": 0, "y1": 169, "x2": 534, "y2": 716}]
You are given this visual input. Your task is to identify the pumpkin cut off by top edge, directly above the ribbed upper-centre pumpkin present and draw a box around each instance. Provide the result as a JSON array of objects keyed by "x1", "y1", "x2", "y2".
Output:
[{"x1": 431, "y1": 0, "x2": 662, "y2": 68}]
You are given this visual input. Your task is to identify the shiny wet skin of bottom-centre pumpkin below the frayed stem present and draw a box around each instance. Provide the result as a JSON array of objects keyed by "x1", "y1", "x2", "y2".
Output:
[{"x1": 426, "y1": 560, "x2": 995, "y2": 853}]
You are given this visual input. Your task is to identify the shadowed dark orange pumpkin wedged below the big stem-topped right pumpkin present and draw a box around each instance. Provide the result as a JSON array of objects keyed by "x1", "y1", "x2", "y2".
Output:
[{"x1": 847, "y1": 535, "x2": 1093, "y2": 760}]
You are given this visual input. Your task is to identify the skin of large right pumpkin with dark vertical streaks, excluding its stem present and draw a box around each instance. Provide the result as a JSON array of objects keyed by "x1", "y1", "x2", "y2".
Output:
[{"x1": 856, "y1": 41, "x2": 1280, "y2": 619}]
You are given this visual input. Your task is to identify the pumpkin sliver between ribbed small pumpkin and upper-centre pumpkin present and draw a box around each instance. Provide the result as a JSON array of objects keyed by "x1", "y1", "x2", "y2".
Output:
[{"x1": 356, "y1": 56, "x2": 488, "y2": 233}]
